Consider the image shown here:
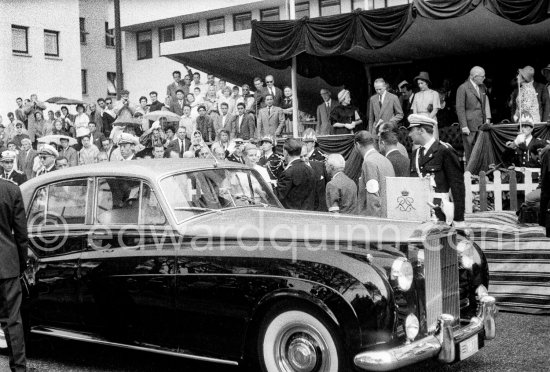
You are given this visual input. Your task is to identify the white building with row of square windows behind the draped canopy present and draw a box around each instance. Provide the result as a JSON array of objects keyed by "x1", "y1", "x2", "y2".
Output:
[{"x1": 121, "y1": 0, "x2": 410, "y2": 107}]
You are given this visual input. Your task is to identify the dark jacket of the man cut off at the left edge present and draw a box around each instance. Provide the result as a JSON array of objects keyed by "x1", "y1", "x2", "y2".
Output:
[{"x1": 0, "y1": 179, "x2": 28, "y2": 279}]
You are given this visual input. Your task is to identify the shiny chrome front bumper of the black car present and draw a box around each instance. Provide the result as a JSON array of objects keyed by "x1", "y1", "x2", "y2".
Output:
[{"x1": 354, "y1": 296, "x2": 496, "y2": 371}]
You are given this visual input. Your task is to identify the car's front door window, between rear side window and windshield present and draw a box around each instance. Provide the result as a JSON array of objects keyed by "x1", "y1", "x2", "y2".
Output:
[{"x1": 94, "y1": 178, "x2": 141, "y2": 225}]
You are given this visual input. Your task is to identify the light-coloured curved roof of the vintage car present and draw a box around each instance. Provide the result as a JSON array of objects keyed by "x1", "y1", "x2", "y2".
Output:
[{"x1": 21, "y1": 158, "x2": 248, "y2": 193}]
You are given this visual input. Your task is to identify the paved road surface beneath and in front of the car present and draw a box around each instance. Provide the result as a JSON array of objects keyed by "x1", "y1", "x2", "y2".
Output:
[{"x1": 0, "y1": 313, "x2": 550, "y2": 372}]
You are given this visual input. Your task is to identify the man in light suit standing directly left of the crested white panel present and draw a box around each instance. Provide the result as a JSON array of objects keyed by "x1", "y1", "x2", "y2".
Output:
[{"x1": 354, "y1": 130, "x2": 395, "y2": 218}]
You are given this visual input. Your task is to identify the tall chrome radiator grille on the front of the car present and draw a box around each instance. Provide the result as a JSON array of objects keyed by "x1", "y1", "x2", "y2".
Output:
[{"x1": 424, "y1": 236, "x2": 460, "y2": 332}]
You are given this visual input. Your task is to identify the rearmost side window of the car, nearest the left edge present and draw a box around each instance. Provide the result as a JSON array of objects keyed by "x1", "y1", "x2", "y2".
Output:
[{"x1": 29, "y1": 179, "x2": 89, "y2": 227}]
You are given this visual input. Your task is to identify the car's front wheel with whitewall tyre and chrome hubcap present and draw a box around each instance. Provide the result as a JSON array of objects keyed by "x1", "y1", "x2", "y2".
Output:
[{"x1": 258, "y1": 309, "x2": 345, "y2": 372}]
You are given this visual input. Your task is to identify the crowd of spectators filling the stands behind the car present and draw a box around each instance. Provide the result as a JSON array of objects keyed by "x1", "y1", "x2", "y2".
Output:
[{"x1": 0, "y1": 65, "x2": 550, "y2": 231}]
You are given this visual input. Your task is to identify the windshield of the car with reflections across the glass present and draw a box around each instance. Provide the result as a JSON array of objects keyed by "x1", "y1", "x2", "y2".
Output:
[{"x1": 160, "y1": 168, "x2": 279, "y2": 223}]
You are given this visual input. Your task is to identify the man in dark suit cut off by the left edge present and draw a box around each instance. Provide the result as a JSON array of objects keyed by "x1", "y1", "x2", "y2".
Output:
[{"x1": 0, "y1": 174, "x2": 28, "y2": 371}]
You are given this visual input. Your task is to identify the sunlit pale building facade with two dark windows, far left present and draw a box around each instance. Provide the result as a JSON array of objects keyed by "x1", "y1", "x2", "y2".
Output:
[{"x1": 0, "y1": 0, "x2": 82, "y2": 117}]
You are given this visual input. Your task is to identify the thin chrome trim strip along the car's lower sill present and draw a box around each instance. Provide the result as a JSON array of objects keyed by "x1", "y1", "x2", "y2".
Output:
[{"x1": 31, "y1": 327, "x2": 239, "y2": 366}]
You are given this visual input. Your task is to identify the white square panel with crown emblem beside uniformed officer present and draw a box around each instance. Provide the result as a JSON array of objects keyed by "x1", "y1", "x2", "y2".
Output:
[{"x1": 386, "y1": 177, "x2": 433, "y2": 222}]
